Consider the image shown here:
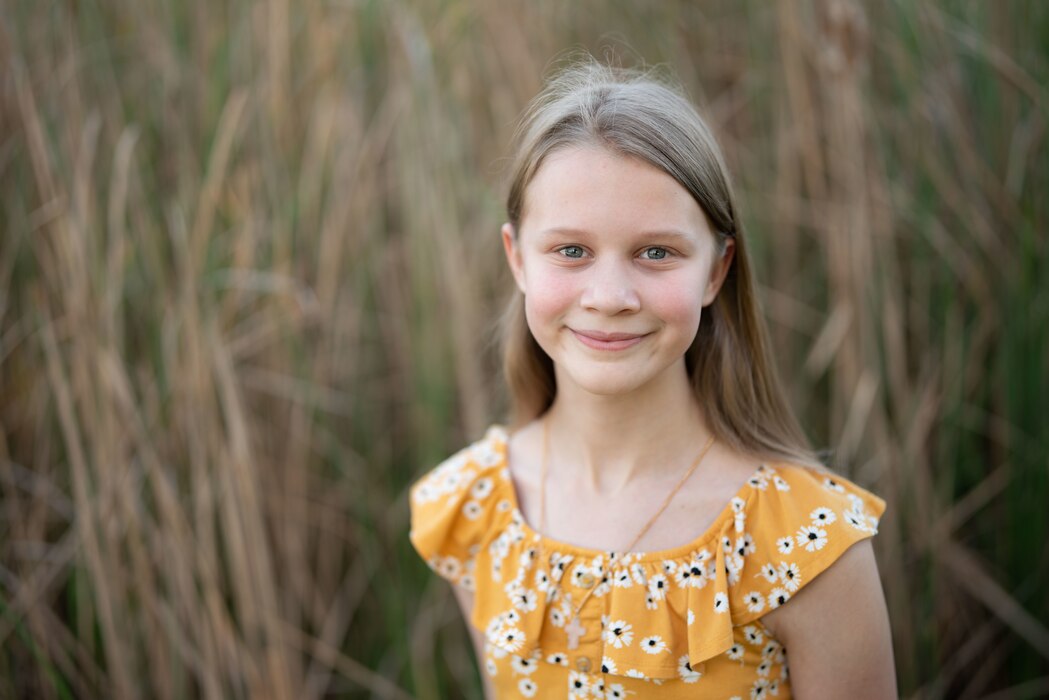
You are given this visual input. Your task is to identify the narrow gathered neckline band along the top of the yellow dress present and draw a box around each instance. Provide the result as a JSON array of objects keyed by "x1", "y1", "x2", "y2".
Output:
[{"x1": 486, "y1": 425, "x2": 768, "y2": 567}]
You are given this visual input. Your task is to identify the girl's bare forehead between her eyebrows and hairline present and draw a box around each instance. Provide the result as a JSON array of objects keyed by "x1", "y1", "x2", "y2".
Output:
[{"x1": 521, "y1": 146, "x2": 710, "y2": 237}]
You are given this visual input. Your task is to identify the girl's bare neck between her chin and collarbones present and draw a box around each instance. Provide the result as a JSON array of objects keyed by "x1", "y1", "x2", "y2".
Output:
[{"x1": 543, "y1": 365, "x2": 710, "y2": 493}]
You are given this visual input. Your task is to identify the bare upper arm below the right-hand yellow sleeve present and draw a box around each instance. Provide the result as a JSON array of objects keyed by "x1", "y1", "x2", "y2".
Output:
[{"x1": 762, "y1": 539, "x2": 897, "y2": 698}]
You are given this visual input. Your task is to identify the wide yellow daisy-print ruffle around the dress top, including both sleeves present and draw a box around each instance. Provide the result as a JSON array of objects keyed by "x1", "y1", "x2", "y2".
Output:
[{"x1": 411, "y1": 424, "x2": 884, "y2": 679}]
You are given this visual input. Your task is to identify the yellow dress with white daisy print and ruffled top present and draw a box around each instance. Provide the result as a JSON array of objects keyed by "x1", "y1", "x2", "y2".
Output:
[{"x1": 410, "y1": 425, "x2": 885, "y2": 700}]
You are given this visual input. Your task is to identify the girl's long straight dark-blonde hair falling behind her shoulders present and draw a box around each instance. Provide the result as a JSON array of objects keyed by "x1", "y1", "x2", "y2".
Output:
[{"x1": 501, "y1": 59, "x2": 821, "y2": 466}]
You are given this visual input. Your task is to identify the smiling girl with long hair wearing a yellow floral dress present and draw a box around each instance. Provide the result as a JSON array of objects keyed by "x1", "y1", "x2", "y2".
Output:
[{"x1": 411, "y1": 63, "x2": 896, "y2": 700}]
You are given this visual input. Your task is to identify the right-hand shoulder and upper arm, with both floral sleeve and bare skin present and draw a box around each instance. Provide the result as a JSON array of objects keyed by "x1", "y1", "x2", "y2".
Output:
[{"x1": 725, "y1": 462, "x2": 895, "y2": 698}]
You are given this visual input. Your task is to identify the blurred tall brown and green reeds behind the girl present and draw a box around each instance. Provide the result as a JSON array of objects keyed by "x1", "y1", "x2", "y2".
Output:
[{"x1": 0, "y1": 0, "x2": 1049, "y2": 699}]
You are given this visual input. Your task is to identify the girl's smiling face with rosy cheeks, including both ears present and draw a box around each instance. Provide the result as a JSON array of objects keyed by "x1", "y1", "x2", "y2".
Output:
[{"x1": 502, "y1": 147, "x2": 733, "y2": 396}]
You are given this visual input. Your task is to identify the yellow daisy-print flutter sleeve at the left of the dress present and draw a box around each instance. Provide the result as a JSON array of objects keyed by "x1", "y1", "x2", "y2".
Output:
[{"x1": 408, "y1": 443, "x2": 501, "y2": 590}]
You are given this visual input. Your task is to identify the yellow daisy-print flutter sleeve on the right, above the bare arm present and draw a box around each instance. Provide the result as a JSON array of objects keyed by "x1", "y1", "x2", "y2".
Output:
[{"x1": 723, "y1": 466, "x2": 885, "y2": 624}]
